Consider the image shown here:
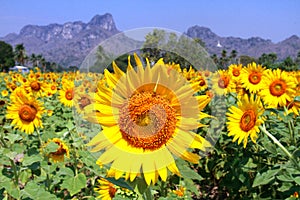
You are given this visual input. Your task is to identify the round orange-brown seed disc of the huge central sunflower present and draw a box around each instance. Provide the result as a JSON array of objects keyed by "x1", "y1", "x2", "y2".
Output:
[{"x1": 119, "y1": 92, "x2": 177, "y2": 150}]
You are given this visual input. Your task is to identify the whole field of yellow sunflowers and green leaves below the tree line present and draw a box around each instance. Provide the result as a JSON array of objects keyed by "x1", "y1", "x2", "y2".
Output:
[{"x1": 0, "y1": 54, "x2": 300, "y2": 200}]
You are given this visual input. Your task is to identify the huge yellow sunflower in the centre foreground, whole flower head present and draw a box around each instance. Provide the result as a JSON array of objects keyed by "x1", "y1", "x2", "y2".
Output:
[{"x1": 88, "y1": 54, "x2": 209, "y2": 185}]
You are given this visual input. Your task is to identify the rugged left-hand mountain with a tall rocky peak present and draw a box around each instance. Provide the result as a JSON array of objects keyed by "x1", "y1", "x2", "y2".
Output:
[{"x1": 0, "y1": 13, "x2": 120, "y2": 66}]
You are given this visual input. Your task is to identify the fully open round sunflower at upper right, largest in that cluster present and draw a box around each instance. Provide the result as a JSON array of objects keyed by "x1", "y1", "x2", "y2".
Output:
[{"x1": 259, "y1": 69, "x2": 296, "y2": 108}]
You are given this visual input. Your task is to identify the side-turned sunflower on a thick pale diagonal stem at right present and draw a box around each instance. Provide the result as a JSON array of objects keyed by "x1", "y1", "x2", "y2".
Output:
[{"x1": 227, "y1": 95, "x2": 264, "y2": 148}]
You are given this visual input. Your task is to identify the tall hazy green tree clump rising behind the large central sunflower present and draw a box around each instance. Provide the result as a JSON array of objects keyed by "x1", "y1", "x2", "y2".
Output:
[{"x1": 141, "y1": 29, "x2": 214, "y2": 68}]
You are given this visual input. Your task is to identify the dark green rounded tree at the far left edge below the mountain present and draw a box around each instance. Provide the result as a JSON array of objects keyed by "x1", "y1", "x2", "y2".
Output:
[{"x1": 0, "y1": 41, "x2": 15, "y2": 71}]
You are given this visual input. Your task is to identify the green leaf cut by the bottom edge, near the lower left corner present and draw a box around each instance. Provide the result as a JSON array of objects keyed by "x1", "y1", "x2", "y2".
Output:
[{"x1": 21, "y1": 181, "x2": 57, "y2": 200}]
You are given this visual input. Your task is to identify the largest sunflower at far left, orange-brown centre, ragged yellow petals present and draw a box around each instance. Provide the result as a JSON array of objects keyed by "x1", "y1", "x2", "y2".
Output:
[{"x1": 6, "y1": 93, "x2": 44, "y2": 134}]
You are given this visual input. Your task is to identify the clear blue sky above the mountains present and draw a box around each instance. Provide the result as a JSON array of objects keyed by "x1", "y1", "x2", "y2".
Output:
[{"x1": 0, "y1": 0, "x2": 300, "y2": 42}]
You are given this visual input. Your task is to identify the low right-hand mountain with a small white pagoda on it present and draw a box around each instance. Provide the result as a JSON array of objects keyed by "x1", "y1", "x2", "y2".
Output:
[{"x1": 186, "y1": 26, "x2": 300, "y2": 59}]
